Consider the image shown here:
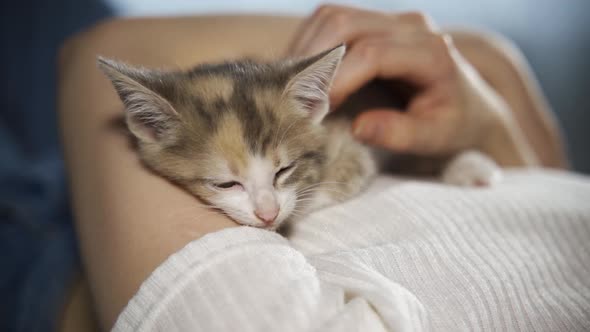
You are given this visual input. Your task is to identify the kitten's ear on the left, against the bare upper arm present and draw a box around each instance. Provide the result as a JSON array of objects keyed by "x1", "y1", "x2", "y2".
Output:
[{"x1": 98, "y1": 56, "x2": 179, "y2": 143}]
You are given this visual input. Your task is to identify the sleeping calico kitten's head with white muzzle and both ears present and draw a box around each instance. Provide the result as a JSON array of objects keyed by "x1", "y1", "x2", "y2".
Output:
[{"x1": 99, "y1": 46, "x2": 345, "y2": 229}]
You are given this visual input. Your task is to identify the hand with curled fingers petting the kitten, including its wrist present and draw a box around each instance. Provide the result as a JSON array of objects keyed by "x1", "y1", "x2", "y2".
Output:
[{"x1": 290, "y1": 5, "x2": 534, "y2": 166}]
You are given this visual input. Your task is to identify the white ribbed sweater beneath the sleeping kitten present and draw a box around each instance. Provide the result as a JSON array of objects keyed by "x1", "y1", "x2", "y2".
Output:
[{"x1": 114, "y1": 171, "x2": 590, "y2": 332}]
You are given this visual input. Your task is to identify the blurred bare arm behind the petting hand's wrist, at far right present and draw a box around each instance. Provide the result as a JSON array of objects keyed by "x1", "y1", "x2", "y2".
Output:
[{"x1": 448, "y1": 30, "x2": 570, "y2": 168}]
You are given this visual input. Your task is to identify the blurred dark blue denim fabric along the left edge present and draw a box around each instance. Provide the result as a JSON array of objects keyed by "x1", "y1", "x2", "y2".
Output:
[{"x1": 0, "y1": 0, "x2": 110, "y2": 332}]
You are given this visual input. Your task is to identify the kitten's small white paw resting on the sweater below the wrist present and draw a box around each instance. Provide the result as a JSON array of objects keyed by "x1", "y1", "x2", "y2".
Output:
[{"x1": 442, "y1": 151, "x2": 502, "y2": 187}]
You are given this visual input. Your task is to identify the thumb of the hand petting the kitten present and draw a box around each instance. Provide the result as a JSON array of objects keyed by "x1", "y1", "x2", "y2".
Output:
[{"x1": 352, "y1": 109, "x2": 429, "y2": 153}]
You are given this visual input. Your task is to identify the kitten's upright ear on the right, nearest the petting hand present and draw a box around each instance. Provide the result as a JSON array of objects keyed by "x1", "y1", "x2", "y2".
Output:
[{"x1": 286, "y1": 44, "x2": 346, "y2": 123}]
